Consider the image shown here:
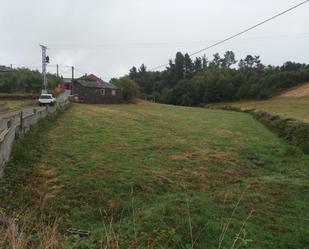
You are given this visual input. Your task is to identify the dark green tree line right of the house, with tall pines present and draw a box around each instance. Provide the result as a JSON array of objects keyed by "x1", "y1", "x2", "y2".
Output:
[{"x1": 127, "y1": 51, "x2": 309, "y2": 106}]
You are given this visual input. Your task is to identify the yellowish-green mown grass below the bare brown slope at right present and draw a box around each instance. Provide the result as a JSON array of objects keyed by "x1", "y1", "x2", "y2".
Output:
[{"x1": 219, "y1": 96, "x2": 309, "y2": 123}]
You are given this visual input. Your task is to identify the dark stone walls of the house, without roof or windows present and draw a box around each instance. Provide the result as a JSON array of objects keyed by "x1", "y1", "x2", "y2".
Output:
[{"x1": 73, "y1": 83, "x2": 122, "y2": 104}]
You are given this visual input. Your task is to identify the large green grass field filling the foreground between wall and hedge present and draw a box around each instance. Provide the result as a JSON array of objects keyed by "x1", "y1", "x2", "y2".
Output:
[{"x1": 0, "y1": 104, "x2": 309, "y2": 248}]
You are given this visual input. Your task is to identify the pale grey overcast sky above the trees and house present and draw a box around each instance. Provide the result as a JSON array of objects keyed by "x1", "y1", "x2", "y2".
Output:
[{"x1": 0, "y1": 0, "x2": 309, "y2": 80}]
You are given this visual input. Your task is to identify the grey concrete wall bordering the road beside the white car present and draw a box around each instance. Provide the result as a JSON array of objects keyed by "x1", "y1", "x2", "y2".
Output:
[{"x1": 0, "y1": 99, "x2": 70, "y2": 177}]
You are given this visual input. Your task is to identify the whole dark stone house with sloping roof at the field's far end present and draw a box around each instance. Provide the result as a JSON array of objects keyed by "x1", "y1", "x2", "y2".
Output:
[{"x1": 73, "y1": 74, "x2": 123, "y2": 104}]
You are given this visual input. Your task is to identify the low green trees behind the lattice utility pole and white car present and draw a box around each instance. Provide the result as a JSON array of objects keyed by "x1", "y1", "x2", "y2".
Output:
[{"x1": 0, "y1": 68, "x2": 61, "y2": 93}]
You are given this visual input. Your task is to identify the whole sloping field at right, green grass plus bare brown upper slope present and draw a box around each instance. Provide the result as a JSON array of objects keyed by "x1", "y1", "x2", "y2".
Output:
[{"x1": 218, "y1": 83, "x2": 309, "y2": 123}]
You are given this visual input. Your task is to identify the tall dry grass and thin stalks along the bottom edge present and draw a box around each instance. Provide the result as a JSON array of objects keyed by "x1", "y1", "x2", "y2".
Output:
[{"x1": 0, "y1": 189, "x2": 253, "y2": 249}]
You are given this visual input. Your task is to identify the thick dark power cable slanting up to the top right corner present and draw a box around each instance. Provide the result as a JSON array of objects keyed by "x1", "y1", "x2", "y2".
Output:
[{"x1": 150, "y1": 0, "x2": 309, "y2": 71}]
